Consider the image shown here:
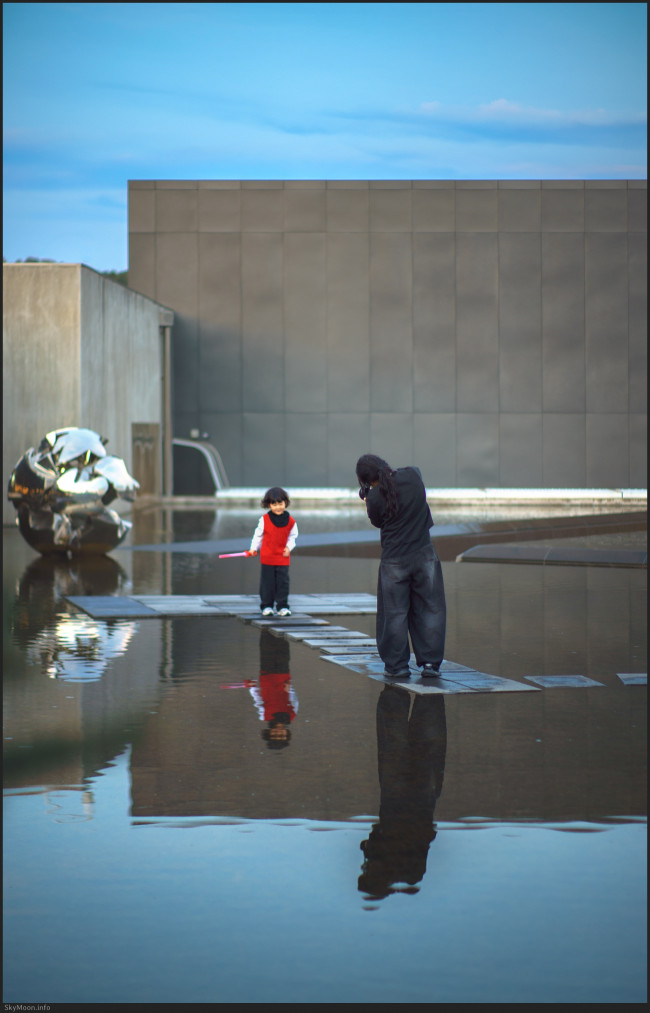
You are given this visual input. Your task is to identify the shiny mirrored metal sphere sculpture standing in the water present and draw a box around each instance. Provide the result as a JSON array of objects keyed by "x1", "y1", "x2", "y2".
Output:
[{"x1": 7, "y1": 426, "x2": 139, "y2": 555}]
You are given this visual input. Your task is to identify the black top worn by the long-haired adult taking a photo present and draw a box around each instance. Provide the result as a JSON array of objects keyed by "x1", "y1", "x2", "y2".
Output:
[{"x1": 365, "y1": 468, "x2": 433, "y2": 559}]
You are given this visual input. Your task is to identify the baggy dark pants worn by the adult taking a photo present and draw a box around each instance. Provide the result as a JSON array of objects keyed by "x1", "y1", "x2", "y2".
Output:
[{"x1": 377, "y1": 545, "x2": 446, "y2": 674}]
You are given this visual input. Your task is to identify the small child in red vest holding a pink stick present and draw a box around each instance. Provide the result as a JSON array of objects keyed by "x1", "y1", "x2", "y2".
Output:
[{"x1": 248, "y1": 485, "x2": 298, "y2": 616}]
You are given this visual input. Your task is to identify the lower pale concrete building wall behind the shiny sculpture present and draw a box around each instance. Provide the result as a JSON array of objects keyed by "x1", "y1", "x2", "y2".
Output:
[{"x1": 3, "y1": 263, "x2": 167, "y2": 524}]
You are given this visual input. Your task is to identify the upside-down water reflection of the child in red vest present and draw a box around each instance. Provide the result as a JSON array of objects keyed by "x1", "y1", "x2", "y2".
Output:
[{"x1": 249, "y1": 630, "x2": 298, "y2": 750}]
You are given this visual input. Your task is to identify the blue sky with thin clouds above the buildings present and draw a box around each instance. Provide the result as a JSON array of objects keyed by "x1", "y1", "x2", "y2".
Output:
[{"x1": 2, "y1": 3, "x2": 647, "y2": 270}]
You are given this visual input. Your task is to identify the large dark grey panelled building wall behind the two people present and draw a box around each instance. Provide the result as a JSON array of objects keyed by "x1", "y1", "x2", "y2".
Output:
[{"x1": 129, "y1": 180, "x2": 647, "y2": 487}]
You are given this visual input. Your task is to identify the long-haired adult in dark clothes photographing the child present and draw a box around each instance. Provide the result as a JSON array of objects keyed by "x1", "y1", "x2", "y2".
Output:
[{"x1": 356, "y1": 454, "x2": 446, "y2": 679}]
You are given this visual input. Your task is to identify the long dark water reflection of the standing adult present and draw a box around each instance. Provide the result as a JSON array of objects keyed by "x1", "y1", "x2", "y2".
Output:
[{"x1": 358, "y1": 686, "x2": 446, "y2": 901}]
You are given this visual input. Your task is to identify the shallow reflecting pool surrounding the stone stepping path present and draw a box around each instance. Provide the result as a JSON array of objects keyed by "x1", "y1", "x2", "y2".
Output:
[{"x1": 4, "y1": 519, "x2": 647, "y2": 1003}]
